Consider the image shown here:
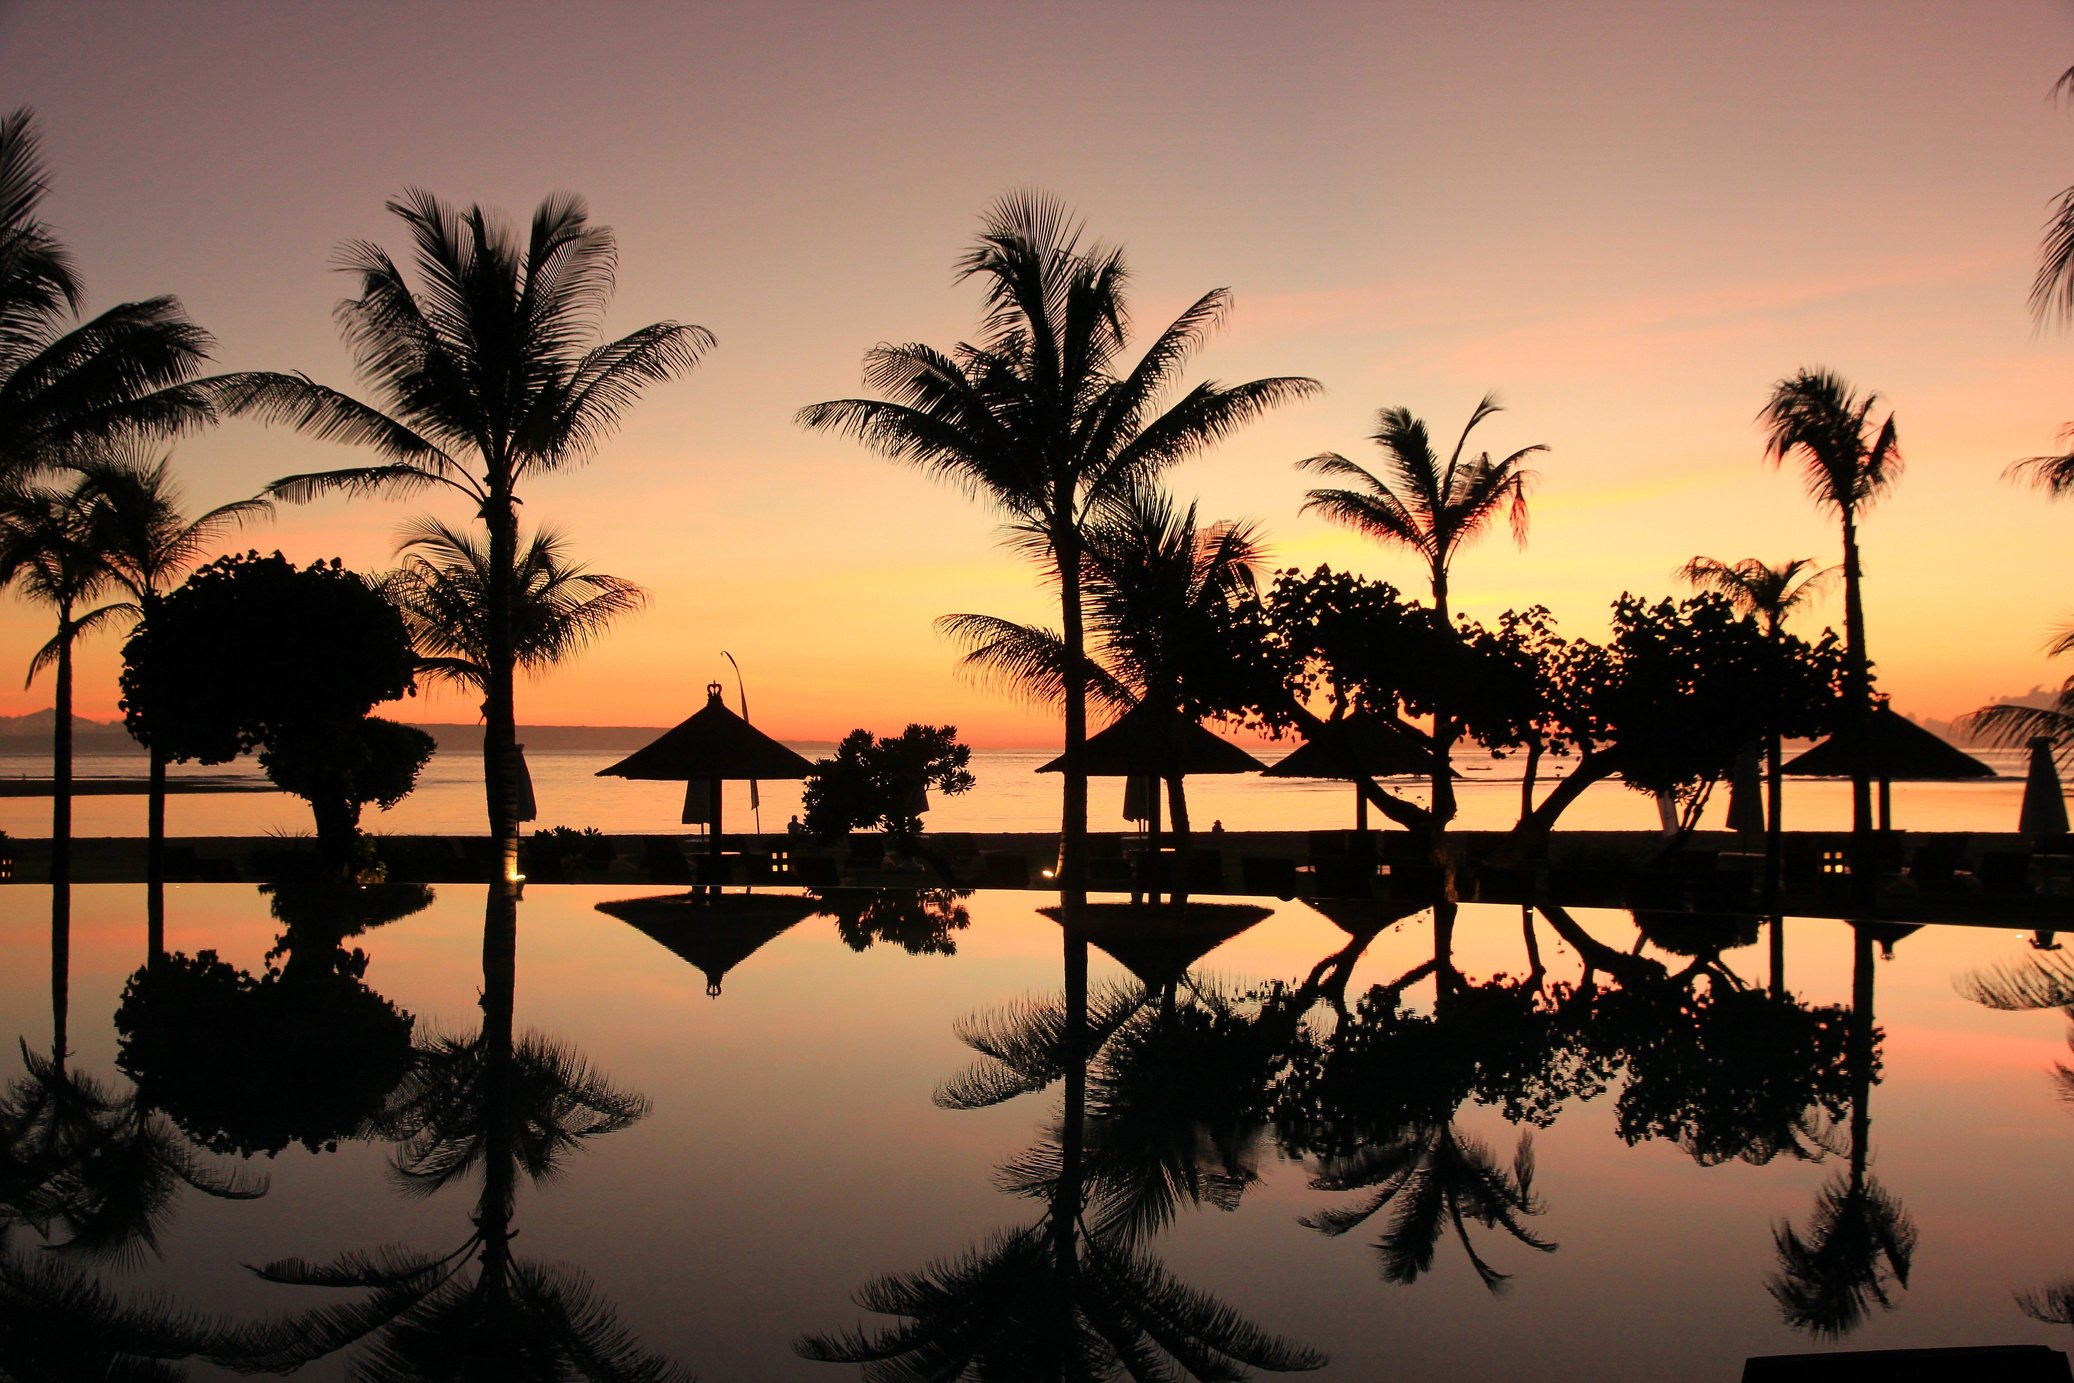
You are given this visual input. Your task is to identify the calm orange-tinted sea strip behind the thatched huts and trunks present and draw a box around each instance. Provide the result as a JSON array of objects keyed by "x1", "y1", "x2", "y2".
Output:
[{"x1": 0, "y1": 751, "x2": 2049, "y2": 836}]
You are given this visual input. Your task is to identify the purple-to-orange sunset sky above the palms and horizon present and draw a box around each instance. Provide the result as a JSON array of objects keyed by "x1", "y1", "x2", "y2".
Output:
[{"x1": 0, "y1": 0, "x2": 2074, "y2": 746}]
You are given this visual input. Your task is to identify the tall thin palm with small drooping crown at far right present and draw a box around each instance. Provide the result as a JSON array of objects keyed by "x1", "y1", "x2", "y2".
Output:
[{"x1": 1757, "y1": 369, "x2": 1902, "y2": 890}]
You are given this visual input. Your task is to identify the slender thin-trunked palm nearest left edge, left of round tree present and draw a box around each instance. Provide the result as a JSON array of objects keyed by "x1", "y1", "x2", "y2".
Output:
[{"x1": 0, "y1": 475, "x2": 133, "y2": 881}]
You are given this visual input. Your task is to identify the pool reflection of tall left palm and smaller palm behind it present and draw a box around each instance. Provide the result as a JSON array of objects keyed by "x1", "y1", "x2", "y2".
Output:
[{"x1": 238, "y1": 885, "x2": 689, "y2": 1383}]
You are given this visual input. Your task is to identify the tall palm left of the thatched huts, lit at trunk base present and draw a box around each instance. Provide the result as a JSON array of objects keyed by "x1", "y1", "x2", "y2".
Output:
[{"x1": 212, "y1": 189, "x2": 713, "y2": 877}]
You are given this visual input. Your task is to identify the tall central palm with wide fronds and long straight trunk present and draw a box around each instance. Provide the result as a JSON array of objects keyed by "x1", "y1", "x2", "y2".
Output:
[{"x1": 798, "y1": 193, "x2": 1317, "y2": 894}]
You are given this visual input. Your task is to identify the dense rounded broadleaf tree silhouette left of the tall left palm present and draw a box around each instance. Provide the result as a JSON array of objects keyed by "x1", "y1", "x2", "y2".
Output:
[{"x1": 122, "y1": 552, "x2": 433, "y2": 875}]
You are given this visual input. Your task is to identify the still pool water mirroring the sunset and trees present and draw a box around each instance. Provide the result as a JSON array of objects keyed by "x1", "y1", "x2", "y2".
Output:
[{"x1": 0, "y1": 885, "x2": 2074, "y2": 1381}]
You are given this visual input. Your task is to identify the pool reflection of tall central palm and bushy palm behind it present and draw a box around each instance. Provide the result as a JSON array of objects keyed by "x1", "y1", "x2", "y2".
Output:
[{"x1": 796, "y1": 904, "x2": 1325, "y2": 1379}]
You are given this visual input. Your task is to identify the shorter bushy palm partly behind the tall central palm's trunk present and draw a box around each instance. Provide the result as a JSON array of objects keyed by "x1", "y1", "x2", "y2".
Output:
[{"x1": 937, "y1": 487, "x2": 1261, "y2": 854}]
